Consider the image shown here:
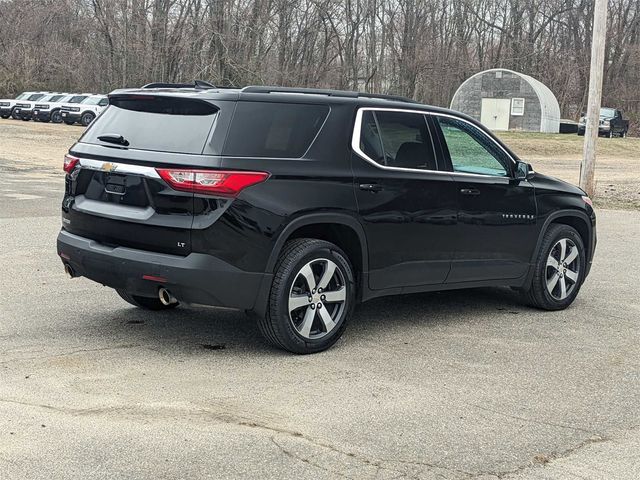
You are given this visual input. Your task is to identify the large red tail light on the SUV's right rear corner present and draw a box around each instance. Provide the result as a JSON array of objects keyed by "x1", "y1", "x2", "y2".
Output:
[{"x1": 156, "y1": 168, "x2": 269, "y2": 197}]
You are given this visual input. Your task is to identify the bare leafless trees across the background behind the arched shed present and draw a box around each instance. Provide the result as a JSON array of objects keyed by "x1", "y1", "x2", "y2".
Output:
[{"x1": 0, "y1": 0, "x2": 640, "y2": 127}]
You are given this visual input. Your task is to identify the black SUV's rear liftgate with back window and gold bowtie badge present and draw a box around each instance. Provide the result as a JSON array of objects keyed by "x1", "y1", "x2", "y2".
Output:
[{"x1": 62, "y1": 93, "x2": 232, "y2": 255}]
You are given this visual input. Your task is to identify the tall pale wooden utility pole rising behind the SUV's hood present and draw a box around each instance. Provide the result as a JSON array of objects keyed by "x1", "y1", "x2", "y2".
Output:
[{"x1": 580, "y1": 0, "x2": 607, "y2": 197}]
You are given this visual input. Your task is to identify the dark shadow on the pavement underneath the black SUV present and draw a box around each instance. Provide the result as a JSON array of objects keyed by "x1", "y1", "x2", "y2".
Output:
[{"x1": 93, "y1": 288, "x2": 530, "y2": 356}]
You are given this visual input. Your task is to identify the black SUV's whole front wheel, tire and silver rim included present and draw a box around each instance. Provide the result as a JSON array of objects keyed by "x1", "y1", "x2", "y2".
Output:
[{"x1": 524, "y1": 224, "x2": 586, "y2": 310}]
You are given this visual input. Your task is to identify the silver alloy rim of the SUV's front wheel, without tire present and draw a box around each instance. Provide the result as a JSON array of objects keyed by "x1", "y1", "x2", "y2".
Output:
[{"x1": 545, "y1": 238, "x2": 580, "y2": 300}]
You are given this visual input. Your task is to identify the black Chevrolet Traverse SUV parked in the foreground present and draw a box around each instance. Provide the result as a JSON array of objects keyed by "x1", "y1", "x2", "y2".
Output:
[{"x1": 57, "y1": 83, "x2": 596, "y2": 353}]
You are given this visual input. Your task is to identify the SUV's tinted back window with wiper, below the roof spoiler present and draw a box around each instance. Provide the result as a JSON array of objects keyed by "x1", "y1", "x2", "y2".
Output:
[{"x1": 82, "y1": 96, "x2": 218, "y2": 154}]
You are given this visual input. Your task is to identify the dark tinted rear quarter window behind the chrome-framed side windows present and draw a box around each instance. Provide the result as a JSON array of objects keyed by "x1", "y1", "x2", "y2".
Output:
[{"x1": 223, "y1": 102, "x2": 329, "y2": 158}]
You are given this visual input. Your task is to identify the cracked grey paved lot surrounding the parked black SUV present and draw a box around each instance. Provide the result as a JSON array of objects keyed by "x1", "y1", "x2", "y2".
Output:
[{"x1": 0, "y1": 121, "x2": 640, "y2": 480}]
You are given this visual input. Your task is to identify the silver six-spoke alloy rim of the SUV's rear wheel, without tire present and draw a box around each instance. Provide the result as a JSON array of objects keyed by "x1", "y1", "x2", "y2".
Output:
[{"x1": 288, "y1": 258, "x2": 347, "y2": 340}]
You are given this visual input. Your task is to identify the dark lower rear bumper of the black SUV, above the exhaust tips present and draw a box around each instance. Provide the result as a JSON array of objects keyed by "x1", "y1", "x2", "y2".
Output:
[{"x1": 57, "y1": 230, "x2": 272, "y2": 310}]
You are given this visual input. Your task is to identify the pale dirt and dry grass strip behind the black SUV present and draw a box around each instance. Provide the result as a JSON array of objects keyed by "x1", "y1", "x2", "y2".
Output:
[{"x1": 0, "y1": 120, "x2": 640, "y2": 210}]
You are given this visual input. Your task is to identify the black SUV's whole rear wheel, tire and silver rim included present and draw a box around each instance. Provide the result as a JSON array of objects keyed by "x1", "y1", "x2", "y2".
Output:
[{"x1": 258, "y1": 238, "x2": 355, "y2": 354}]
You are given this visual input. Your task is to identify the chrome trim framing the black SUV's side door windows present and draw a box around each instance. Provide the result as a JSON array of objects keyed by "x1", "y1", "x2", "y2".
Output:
[{"x1": 351, "y1": 107, "x2": 516, "y2": 179}]
